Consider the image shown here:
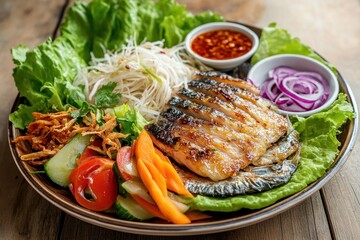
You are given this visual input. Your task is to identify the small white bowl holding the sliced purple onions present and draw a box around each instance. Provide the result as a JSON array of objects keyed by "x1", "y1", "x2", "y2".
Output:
[{"x1": 247, "y1": 54, "x2": 339, "y2": 117}]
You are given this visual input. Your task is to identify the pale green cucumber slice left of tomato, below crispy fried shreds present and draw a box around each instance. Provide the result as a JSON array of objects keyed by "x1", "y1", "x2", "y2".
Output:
[{"x1": 44, "y1": 134, "x2": 91, "y2": 187}]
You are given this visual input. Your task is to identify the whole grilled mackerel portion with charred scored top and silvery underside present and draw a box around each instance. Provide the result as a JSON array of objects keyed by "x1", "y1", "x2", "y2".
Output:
[{"x1": 147, "y1": 72, "x2": 300, "y2": 196}]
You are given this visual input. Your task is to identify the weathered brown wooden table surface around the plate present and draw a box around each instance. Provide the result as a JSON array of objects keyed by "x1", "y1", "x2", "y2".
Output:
[{"x1": 0, "y1": 0, "x2": 360, "y2": 240}]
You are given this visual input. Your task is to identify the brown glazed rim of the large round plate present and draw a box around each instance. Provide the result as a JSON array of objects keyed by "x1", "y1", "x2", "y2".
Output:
[{"x1": 8, "y1": 23, "x2": 358, "y2": 236}]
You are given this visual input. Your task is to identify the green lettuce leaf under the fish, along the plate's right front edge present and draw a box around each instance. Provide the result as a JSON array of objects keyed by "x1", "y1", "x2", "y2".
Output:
[{"x1": 190, "y1": 93, "x2": 354, "y2": 212}]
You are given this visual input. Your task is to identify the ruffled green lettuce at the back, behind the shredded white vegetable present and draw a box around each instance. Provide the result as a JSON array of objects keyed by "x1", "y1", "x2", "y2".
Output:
[{"x1": 60, "y1": 0, "x2": 224, "y2": 58}]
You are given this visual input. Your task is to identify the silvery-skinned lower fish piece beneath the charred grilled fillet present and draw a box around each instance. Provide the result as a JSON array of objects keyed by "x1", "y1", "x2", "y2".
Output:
[{"x1": 174, "y1": 130, "x2": 300, "y2": 197}]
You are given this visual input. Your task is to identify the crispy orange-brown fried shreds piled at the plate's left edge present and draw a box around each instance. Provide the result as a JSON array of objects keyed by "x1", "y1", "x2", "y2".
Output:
[{"x1": 12, "y1": 110, "x2": 128, "y2": 166}]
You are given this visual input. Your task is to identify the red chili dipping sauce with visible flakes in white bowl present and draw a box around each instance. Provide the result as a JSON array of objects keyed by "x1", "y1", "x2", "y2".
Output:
[{"x1": 191, "y1": 30, "x2": 252, "y2": 60}]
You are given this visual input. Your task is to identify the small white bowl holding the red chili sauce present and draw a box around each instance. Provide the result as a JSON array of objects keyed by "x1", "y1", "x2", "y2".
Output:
[{"x1": 185, "y1": 22, "x2": 259, "y2": 71}]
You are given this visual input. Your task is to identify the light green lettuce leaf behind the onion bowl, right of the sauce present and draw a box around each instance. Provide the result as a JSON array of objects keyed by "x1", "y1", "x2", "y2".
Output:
[{"x1": 251, "y1": 23, "x2": 337, "y2": 74}]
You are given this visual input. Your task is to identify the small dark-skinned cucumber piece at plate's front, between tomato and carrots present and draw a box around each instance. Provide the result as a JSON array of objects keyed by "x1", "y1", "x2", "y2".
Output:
[{"x1": 115, "y1": 195, "x2": 154, "y2": 221}]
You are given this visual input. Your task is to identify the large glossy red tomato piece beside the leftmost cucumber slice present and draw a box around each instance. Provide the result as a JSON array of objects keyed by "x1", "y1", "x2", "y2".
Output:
[{"x1": 69, "y1": 157, "x2": 118, "y2": 211}]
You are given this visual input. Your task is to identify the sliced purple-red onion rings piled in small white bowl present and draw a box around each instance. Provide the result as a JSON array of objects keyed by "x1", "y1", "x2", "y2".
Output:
[{"x1": 260, "y1": 66, "x2": 329, "y2": 112}]
